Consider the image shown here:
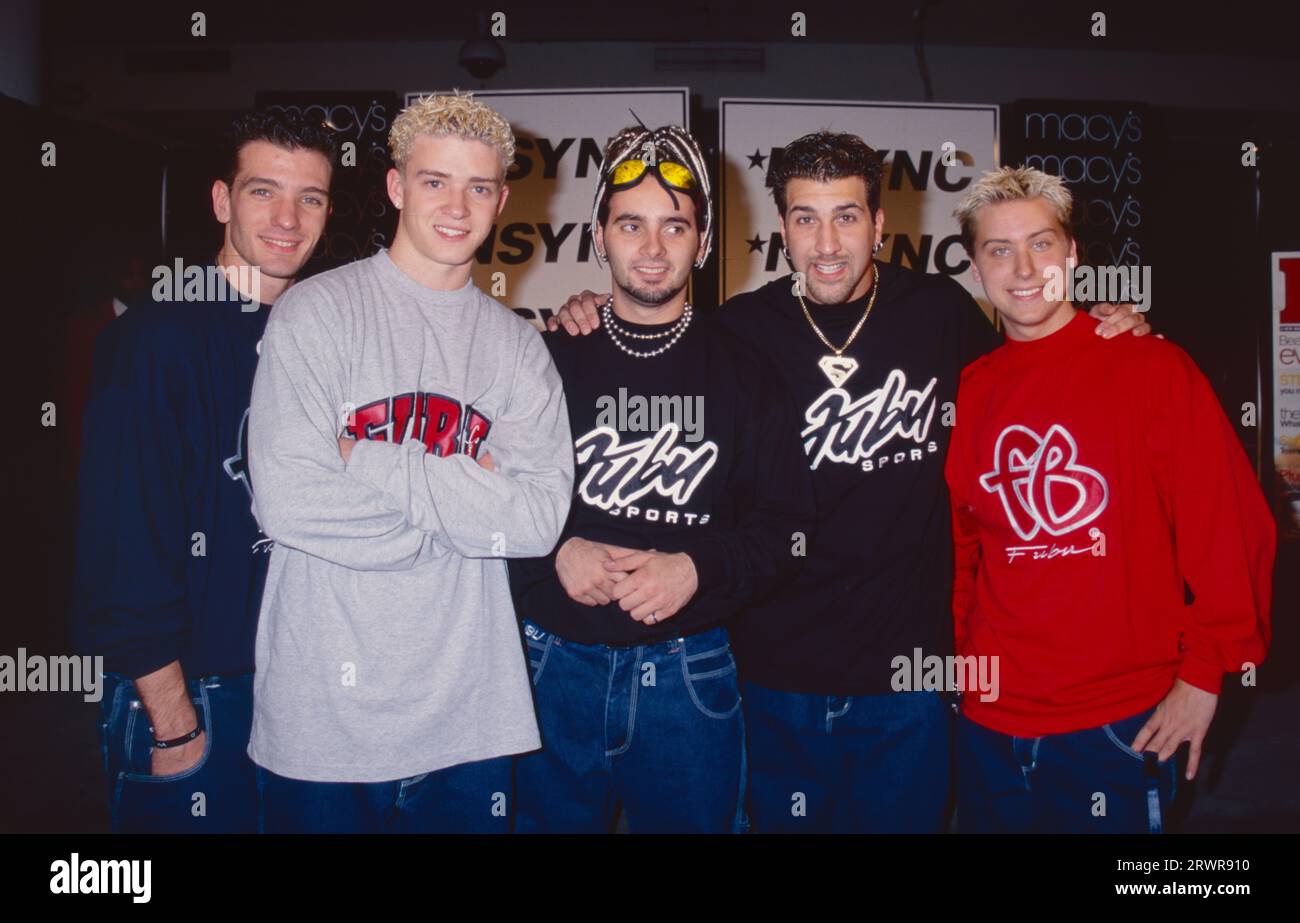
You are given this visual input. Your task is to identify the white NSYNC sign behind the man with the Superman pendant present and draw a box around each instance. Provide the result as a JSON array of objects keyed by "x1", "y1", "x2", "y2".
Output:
[{"x1": 719, "y1": 99, "x2": 998, "y2": 311}]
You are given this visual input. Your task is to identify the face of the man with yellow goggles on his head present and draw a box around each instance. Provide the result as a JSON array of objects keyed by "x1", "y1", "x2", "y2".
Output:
[{"x1": 595, "y1": 178, "x2": 705, "y2": 322}]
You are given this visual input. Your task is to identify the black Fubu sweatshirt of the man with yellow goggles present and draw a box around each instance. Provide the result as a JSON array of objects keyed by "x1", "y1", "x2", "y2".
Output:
[{"x1": 510, "y1": 313, "x2": 813, "y2": 646}]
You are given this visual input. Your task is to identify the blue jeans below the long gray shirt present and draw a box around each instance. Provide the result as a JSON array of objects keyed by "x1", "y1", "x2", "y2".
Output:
[{"x1": 257, "y1": 757, "x2": 511, "y2": 833}]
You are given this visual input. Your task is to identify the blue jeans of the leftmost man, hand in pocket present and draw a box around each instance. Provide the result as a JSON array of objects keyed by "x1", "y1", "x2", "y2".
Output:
[{"x1": 99, "y1": 673, "x2": 257, "y2": 833}]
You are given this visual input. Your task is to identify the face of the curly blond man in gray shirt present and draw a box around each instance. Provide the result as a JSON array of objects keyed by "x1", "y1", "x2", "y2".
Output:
[{"x1": 387, "y1": 135, "x2": 510, "y2": 290}]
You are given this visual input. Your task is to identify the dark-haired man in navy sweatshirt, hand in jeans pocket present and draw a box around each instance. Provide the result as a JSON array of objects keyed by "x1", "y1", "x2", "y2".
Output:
[{"x1": 73, "y1": 111, "x2": 337, "y2": 832}]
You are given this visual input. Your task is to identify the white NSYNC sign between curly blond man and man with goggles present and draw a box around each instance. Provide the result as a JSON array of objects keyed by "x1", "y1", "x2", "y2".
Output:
[{"x1": 406, "y1": 87, "x2": 690, "y2": 326}]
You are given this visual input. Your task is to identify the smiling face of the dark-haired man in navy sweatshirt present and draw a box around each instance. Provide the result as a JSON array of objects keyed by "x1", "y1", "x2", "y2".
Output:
[{"x1": 212, "y1": 140, "x2": 330, "y2": 302}]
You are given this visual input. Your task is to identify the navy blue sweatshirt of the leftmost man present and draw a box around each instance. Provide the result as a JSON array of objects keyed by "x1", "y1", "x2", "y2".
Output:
[{"x1": 73, "y1": 267, "x2": 270, "y2": 679}]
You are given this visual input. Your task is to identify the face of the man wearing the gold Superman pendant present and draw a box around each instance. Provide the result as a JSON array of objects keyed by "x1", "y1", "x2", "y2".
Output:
[{"x1": 781, "y1": 177, "x2": 885, "y2": 304}]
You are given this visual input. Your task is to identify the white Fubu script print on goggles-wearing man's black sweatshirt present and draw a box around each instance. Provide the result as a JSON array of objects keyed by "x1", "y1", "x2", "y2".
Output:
[{"x1": 573, "y1": 423, "x2": 718, "y2": 510}]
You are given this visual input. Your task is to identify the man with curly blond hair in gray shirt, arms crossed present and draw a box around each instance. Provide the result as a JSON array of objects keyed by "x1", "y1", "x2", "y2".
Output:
[{"x1": 248, "y1": 90, "x2": 573, "y2": 832}]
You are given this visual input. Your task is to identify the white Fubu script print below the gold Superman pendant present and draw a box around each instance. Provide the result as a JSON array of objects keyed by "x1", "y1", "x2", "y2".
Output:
[{"x1": 800, "y1": 369, "x2": 939, "y2": 469}]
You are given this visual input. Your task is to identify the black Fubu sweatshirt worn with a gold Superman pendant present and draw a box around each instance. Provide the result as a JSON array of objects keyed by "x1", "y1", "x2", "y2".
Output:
[{"x1": 716, "y1": 264, "x2": 998, "y2": 696}]
